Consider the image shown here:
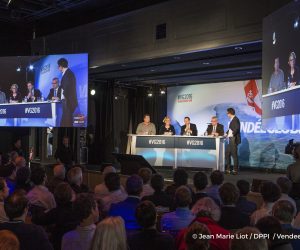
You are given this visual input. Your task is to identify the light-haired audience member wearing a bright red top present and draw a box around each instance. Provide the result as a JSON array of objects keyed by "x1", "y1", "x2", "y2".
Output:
[{"x1": 176, "y1": 197, "x2": 230, "y2": 250}]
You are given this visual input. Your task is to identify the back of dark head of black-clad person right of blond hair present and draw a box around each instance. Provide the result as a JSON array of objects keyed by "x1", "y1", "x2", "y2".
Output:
[{"x1": 135, "y1": 201, "x2": 156, "y2": 229}]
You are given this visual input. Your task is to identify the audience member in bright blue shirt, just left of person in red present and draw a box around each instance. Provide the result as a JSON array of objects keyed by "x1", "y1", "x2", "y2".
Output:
[{"x1": 161, "y1": 186, "x2": 195, "y2": 235}]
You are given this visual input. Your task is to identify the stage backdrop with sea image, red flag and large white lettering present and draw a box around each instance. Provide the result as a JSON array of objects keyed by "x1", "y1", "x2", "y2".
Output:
[{"x1": 167, "y1": 80, "x2": 300, "y2": 169}]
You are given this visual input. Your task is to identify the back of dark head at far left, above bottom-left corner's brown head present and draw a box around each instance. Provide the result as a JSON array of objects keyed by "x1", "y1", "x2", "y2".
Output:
[{"x1": 4, "y1": 192, "x2": 28, "y2": 220}]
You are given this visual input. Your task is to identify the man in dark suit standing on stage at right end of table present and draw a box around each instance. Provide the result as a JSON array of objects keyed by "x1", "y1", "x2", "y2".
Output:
[{"x1": 225, "y1": 108, "x2": 241, "y2": 175}]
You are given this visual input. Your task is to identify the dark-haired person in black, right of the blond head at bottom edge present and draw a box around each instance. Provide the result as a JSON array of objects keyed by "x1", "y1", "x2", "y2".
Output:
[{"x1": 128, "y1": 201, "x2": 175, "y2": 250}]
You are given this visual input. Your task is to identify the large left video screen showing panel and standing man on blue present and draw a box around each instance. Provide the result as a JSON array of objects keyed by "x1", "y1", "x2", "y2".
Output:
[{"x1": 0, "y1": 54, "x2": 88, "y2": 127}]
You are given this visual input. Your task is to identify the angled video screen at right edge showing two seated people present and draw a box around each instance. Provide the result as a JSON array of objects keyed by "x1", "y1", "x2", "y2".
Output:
[{"x1": 262, "y1": 1, "x2": 300, "y2": 130}]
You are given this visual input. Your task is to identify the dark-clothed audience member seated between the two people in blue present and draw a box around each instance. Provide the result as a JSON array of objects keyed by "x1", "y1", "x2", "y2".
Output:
[{"x1": 142, "y1": 174, "x2": 173, "y2": 211}]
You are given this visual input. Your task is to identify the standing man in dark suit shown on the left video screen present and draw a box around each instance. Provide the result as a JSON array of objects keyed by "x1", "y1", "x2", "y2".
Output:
[{"x1": 57, "y1": 58, "x2": 78, "y2": 127}]
